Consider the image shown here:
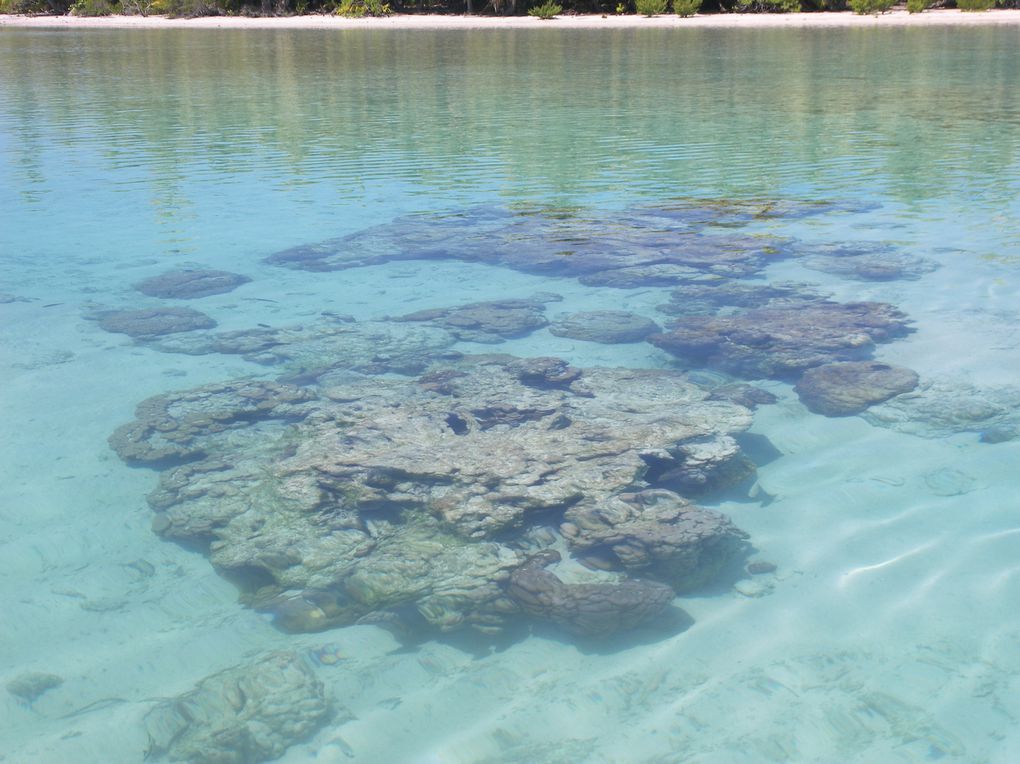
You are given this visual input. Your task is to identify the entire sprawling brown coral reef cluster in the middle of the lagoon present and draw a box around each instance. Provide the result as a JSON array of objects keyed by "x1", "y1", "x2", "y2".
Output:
[{"x1": 111, "y1": 197, "x2": 928, "y2": 656}]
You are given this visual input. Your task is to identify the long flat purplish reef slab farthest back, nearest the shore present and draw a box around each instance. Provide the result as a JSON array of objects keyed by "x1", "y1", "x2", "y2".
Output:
[{"x1": 267, "y1": 207, "x2": 780, "y2": 289}]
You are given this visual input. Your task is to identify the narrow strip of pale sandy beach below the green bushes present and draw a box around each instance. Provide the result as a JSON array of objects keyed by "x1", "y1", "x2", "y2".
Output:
[{"x1": 0, "y1": 10, "x2": 1020, "y2": 30}]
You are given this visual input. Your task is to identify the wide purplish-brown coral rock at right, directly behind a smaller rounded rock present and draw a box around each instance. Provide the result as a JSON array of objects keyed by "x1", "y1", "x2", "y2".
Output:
[{"x1": 649, "y1": 300, "x2": 909, "y2": 378}]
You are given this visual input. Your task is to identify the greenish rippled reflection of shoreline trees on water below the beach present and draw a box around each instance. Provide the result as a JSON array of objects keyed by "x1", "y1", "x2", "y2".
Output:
[{"x1": 0, "y1": 29, "x2": 1020, "y2": 203}]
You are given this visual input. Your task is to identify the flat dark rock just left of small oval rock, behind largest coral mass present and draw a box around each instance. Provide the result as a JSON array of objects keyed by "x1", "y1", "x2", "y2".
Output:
[{"x1": 394, "y1": 294, "x2": 563, "y2": 343}]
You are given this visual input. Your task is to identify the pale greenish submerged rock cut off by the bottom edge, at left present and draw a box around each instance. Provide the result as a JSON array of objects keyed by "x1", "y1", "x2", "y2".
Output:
[{"x1": 144, "y1": 653, "x2": 335, "y2": 764}]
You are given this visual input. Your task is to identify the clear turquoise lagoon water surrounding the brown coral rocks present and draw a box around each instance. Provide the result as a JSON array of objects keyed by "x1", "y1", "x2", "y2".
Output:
[{"x1": 0, "y1": 23, "x2": 1020, "y2": 764}]
